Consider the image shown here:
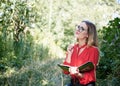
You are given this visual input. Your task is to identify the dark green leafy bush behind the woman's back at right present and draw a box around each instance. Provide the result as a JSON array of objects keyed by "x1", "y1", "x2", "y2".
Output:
[{"x1": 98, "y1": 18, "x2": 120, "y2": 86}]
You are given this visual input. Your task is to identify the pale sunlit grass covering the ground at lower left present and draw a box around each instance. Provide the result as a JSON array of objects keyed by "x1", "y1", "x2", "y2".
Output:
[{"x1": 0, "y1": 59, "x2": 62, "y2": 86}]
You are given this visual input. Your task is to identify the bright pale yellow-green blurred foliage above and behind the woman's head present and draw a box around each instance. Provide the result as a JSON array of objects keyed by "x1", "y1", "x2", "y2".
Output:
[{"x1": 33, "y1": 0, "x2": 119, "y2": 50}]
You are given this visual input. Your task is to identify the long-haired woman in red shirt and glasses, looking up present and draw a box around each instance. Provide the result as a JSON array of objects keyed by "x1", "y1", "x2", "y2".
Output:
[{"x1": 63, "y1": 21, "x2": 99, "y2": 86}]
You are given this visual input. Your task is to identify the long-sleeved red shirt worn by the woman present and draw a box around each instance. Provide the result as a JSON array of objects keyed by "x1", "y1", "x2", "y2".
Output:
[{"x1": 64, "y1": 44, "x2": 99, "y2": 85}]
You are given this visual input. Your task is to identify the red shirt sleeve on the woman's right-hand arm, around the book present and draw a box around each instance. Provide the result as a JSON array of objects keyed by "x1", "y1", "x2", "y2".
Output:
[{"x1": 79, "y1": 46, "x2": 99, "y2": 84}]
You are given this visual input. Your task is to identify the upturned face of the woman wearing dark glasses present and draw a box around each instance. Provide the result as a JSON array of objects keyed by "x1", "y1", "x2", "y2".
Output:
[{"x1": 75, "y1": 22, "x2": 88, "y2": 40}]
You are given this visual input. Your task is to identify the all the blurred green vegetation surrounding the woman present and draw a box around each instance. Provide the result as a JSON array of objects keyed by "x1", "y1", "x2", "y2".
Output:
[{"x1": 0, "y1": 0, "x2": 120, "y2": 86}]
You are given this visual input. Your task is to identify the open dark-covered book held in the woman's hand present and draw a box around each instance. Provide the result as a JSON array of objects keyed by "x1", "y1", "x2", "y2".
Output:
[{"x1": 58, "y1": 62, "x2": 94, "y2": 73}]
